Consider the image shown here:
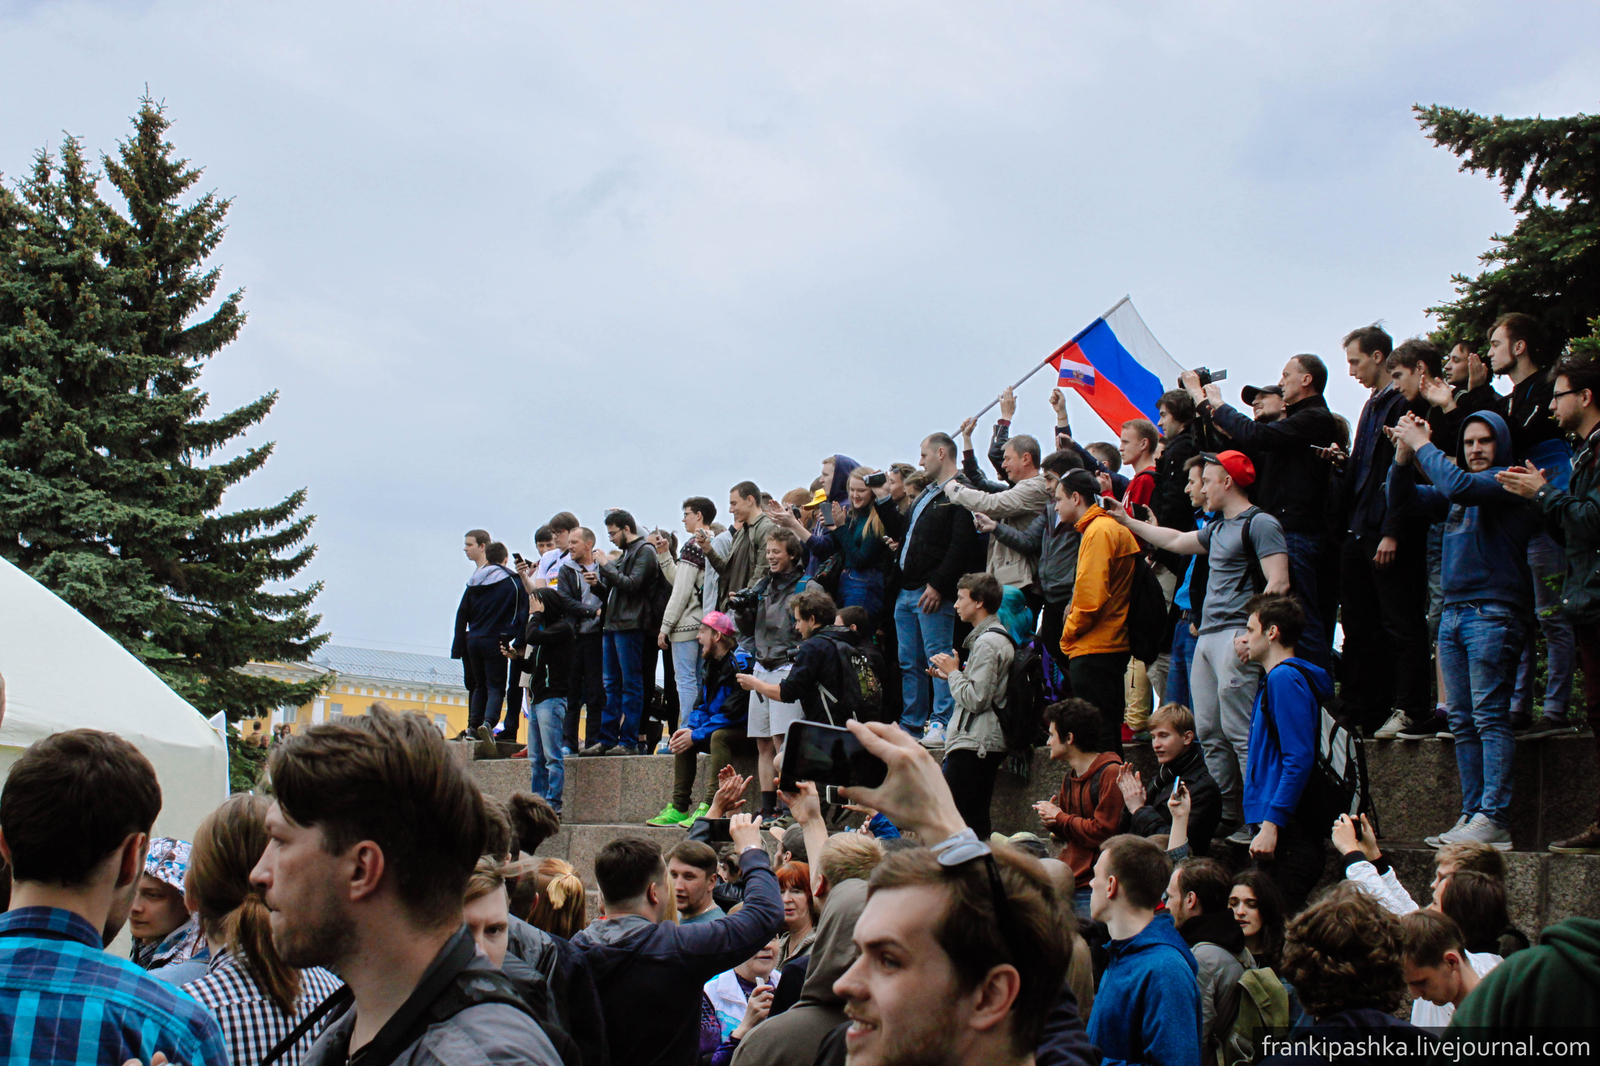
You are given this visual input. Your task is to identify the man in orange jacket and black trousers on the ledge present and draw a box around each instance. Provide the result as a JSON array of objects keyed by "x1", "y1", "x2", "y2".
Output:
[{"x1": 1056, "y1": 471, "x2": 1139, "y2": 751}]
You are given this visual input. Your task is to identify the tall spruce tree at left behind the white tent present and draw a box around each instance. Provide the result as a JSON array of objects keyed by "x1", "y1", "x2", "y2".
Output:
[{"x1": 0, "y1": 98, "x2": 326, "y2": 719}]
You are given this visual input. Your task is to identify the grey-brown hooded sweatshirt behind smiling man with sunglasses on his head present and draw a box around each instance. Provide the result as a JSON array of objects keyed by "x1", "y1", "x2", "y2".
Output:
[{"x1": 733, "y1": 877, "x2": 867, "y2": 1066}]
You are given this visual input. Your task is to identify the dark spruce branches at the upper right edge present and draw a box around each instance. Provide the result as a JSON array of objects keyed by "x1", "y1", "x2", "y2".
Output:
[{"x1": 1414, "y1": 107, "x2": 1600, "y2": 354}]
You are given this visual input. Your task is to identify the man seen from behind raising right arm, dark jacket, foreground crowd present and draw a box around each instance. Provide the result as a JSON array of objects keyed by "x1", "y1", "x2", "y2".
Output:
[{"x1": 573, "y1": 815, "x2": 784, "y2": 1066}]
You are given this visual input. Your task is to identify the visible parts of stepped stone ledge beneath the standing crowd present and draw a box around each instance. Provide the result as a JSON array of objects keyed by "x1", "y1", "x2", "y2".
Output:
[{"x1": 462, "y1": 736, "x2": 1600, "y2": 933}]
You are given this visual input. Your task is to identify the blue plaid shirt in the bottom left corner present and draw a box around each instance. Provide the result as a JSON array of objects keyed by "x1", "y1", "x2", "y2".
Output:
[{"x1": 0, "y1": 908, "x2": 229, "y2": 1066}]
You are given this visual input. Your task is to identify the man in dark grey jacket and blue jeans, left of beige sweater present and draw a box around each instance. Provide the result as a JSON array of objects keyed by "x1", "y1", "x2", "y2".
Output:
[{"x1": 578, "y1": 511, "x2": 661, "y2": 755}]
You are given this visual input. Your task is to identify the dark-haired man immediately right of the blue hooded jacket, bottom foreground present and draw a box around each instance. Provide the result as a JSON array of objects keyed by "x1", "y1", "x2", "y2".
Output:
[{"x1": 1166, "y1": 858, "x2": 1256, "y2": 1047}]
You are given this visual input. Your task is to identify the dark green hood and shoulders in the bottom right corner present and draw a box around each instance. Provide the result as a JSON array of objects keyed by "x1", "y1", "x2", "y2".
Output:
[{"x1": 1450, "y1": 917, "x2": 1600, "y2": 1032}]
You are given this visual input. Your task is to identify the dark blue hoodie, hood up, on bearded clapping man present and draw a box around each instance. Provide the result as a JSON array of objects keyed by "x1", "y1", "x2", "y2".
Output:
[{"x1": 1389, "y1": 411, "x2": 1539, "y2": 615}]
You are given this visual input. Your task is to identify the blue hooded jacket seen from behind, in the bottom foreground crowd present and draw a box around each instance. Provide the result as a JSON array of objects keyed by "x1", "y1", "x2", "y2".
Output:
[{"x1": 1090, "y1": 911, "x2": 1200, "y2": 1066}]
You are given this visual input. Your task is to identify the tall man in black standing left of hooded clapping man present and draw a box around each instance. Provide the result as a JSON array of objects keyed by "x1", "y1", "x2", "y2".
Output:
[{"x1": 1315, "y1": 325, "x2": 1434, "y2": 739}]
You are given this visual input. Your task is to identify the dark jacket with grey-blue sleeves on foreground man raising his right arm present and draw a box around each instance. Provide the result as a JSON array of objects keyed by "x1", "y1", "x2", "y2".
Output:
[{"x1": 573, "y1": 848, "x2": 784, "y2": 1066}]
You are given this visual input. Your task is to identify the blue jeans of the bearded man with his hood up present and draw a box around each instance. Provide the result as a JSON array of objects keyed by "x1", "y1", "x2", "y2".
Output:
[{"x1": 1438, "y1": 602, "x2": 1528, "y2": 829}]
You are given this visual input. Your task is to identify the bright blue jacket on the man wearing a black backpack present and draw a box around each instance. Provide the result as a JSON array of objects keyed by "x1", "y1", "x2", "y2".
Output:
[{"x1": 1245, "y1": 658, "x2": 1333, "y2": 829}]
